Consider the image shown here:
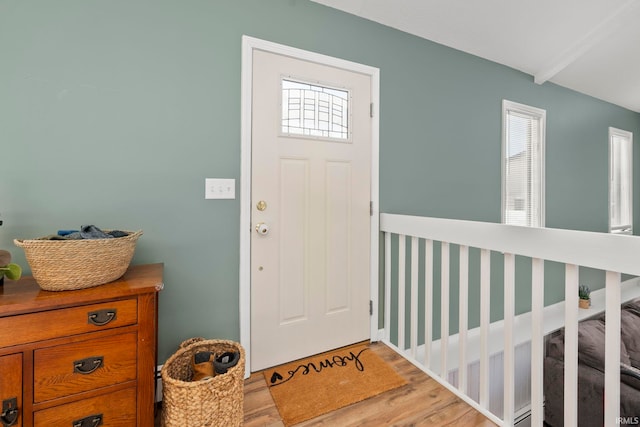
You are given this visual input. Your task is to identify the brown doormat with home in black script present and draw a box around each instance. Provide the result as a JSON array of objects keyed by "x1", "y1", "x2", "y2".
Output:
[{"x1": 264, "y1": 344, "x2": 407, "y2": 426}]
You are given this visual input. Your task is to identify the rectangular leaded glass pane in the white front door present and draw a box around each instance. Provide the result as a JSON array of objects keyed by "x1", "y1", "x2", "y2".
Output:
[{"x1": 282, "y1": 79, "x2": 350, "y2": 141}]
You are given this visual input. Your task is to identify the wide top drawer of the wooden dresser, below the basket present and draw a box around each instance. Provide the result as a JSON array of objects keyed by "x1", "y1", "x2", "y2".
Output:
[{"x1": 0, "y1": 298, "x2": 138, "y2": 347}]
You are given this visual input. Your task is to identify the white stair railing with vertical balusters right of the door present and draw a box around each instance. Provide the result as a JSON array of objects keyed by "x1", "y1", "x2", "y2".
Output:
[{"x1": 380, "y1": 214, "x2": 640, "y2": 427}]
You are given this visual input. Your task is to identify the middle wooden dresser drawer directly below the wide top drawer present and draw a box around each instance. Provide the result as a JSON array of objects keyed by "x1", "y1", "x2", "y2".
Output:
[{"x1": 33, "y1": 332, "x2": 137, "y2": 403}]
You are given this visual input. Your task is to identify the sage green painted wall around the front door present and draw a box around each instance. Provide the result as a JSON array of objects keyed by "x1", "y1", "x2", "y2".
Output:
[{"x1": 0, "y1": 0, "x2": 640, "y2": 361}]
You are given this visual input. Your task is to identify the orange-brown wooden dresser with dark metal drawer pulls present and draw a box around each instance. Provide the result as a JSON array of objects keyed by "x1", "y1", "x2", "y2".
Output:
[{"x1": 0, "y1": 264, "x2": 163, "y2": 427}]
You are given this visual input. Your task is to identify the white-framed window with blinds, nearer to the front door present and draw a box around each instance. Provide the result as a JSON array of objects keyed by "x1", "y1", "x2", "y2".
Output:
[{"x1": 502, "y1": 100, "x2": 546, "y2": 227}]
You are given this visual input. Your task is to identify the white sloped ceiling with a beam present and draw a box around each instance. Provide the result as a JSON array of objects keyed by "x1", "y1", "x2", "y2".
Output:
[{"x1": 312, "y1": 0, "x2": 640, "y2": 112}]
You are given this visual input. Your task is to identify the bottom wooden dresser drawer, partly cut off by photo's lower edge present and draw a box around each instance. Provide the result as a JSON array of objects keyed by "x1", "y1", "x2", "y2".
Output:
[{"x1": 33, "y1": 388, "x2": 136, "y2": 427}]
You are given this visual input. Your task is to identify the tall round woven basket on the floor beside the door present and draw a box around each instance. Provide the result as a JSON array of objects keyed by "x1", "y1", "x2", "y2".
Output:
[{"x1": 162, "y1": 338, "x2": 245, "y2": 427}]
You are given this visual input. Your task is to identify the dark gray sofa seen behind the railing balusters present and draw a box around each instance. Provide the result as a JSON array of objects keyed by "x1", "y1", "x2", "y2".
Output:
[{"x1": 544, "y1": 299, "x2": 640, "y2": 427}]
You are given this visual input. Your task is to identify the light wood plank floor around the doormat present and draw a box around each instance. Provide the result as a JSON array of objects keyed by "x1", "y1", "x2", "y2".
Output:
[{"x1": 156, "y1": 343, "x2": 495, "y2": 427}]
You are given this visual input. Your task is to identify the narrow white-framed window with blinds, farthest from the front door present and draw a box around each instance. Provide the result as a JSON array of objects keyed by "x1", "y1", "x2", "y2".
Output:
[{"x1": 609, "y1": 128, "x2": 633, "y2": 234}]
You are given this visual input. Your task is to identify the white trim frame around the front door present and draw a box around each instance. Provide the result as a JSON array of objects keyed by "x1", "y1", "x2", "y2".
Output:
[{"x1": 239, "y1": 35, "x2": 380, "y2": 377}]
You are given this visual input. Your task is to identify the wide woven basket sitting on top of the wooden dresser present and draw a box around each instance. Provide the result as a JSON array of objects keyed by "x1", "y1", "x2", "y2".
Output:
[{"x1": 13, "y1": 231, "x2": 142, "y2": 291}]
